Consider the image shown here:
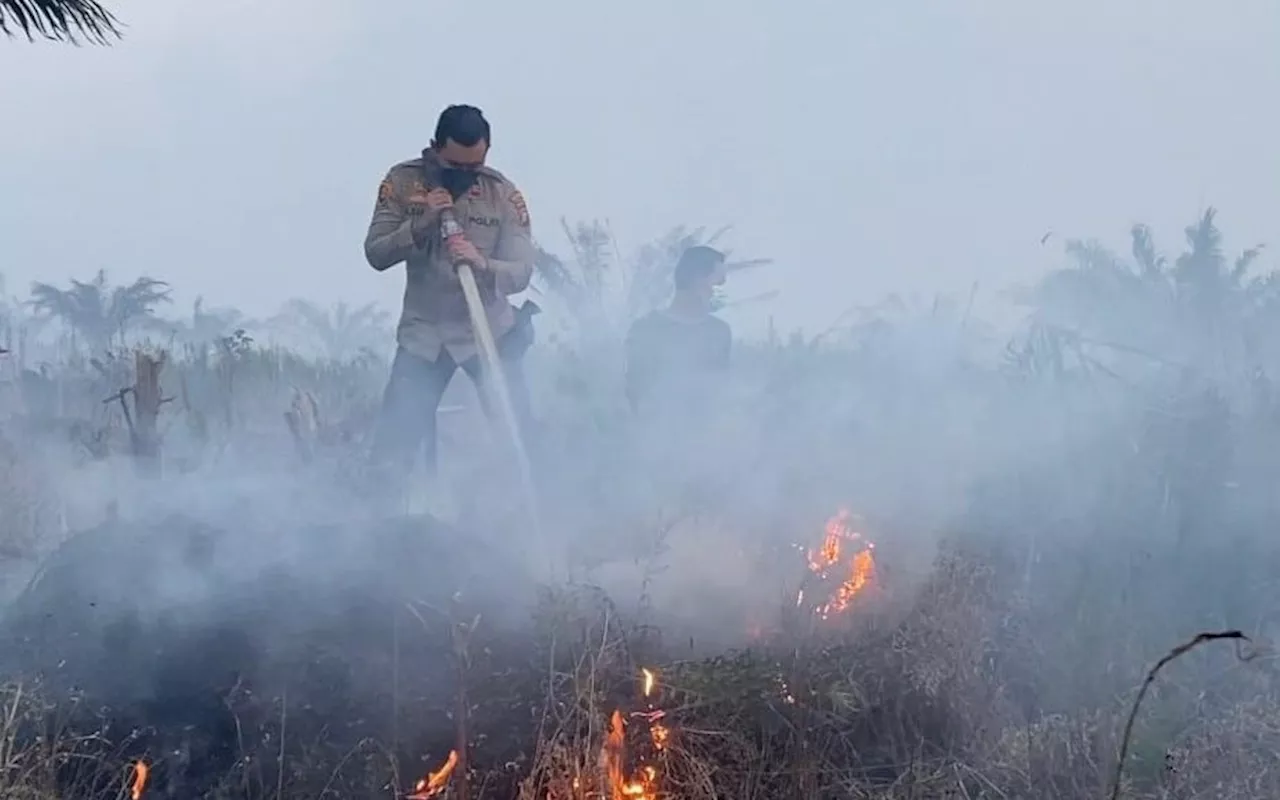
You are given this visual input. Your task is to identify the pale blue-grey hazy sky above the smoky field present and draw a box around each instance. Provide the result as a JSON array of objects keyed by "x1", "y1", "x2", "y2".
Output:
[{"x1": 0, "y1": 0, "x2": 1280, "y2": 329}]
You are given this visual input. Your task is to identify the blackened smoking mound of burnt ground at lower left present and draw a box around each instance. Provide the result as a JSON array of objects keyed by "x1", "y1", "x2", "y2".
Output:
[{"x1": 0, "y1": 516, "x2": 538, "y2": 799}]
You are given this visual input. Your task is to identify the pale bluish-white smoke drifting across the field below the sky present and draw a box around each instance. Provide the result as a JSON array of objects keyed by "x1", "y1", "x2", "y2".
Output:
[{"x1": 0, "y1": 207, "x2": 1280, "y2": 799}]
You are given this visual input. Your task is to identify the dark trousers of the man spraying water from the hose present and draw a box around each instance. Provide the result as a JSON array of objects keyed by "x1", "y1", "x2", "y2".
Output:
[{"x1": 372, "y1": 332, "x2": 531, "y2": 475}]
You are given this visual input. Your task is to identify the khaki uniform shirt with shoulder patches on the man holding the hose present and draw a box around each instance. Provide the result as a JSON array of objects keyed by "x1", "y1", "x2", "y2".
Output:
[{"x1": 365, "y1": 152, "x2": 535, "y2": 364}]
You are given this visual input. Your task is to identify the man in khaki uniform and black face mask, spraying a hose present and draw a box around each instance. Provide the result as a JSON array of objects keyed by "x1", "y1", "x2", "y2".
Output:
[{"x1": 365, "y1": 105, "x2": 536, "y2": 474}]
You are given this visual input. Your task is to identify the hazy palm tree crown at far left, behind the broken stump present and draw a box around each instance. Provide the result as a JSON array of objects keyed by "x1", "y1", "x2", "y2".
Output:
[{"x1": 28, "y1": 270, "x2": 172, "y2": 351}]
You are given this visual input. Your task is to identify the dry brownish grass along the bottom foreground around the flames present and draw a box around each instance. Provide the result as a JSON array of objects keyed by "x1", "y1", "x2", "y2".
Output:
[{"x1": 0, "y1": 529, "x2": 1280, "y2": 800}]
